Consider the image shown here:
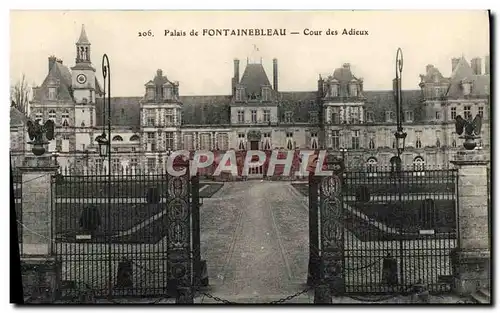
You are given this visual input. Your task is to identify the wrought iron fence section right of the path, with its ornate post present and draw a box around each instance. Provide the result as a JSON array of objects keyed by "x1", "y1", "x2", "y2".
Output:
[{"x1": 317, "y1": 168, "x2": 458, "y2": 294}]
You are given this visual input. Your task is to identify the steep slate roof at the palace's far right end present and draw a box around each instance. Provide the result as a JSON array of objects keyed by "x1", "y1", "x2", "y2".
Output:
[{"x1": 447, "y1": 57, "x2": 490, "y2": 99}]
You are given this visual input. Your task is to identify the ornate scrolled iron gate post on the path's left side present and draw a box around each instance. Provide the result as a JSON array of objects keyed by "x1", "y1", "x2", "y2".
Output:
[{"x1": 167, "y1": 164, "x2": 192, "y2": 300}]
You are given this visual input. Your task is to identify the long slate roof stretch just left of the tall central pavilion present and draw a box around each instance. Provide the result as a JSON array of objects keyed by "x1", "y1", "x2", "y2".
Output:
[{"x1": 180, "y1": 95, "x2": 232, "y2": 125}]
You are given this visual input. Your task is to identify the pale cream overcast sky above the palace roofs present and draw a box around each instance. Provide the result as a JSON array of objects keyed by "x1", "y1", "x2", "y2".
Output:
[{"x1": 10, "y1": 11, "x2": 489, "y2": 96}]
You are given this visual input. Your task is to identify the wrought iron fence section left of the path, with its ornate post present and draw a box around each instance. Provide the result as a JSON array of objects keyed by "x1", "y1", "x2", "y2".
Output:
[{"x1": 53, "y1": 165, "x2": 199, "y2": 298}]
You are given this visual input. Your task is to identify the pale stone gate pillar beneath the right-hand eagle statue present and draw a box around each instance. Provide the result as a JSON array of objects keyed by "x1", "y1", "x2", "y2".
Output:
[{"x1": 451, "y1": 150, "x2": 491, "y2": 295}]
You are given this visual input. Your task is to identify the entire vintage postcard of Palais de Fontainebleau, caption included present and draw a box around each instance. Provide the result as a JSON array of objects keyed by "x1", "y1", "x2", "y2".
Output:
[{"x1": 10, "y1": 11, "x2": 492, "y2": 304}]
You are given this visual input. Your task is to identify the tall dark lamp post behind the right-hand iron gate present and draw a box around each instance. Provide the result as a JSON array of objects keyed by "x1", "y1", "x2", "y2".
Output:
[{"x1": 394, "y1": 48, "x2": 407, "y2": 286}]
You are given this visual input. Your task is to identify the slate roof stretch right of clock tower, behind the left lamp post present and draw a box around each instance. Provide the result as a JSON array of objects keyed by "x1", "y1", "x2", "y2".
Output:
[{"x1": 95, "y1": 97, "x2": 142, "y2": 128}]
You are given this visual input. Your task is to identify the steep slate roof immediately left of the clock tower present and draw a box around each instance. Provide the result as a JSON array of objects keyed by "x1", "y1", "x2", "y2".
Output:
[{"x1": 33, "y1": 62, "x2": 73, "y2": 101}]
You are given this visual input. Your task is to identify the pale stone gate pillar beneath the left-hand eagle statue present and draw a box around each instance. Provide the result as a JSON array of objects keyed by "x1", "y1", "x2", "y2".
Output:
[{"x1": 19, "y1": 156, "x2": 61, "y2": 303}]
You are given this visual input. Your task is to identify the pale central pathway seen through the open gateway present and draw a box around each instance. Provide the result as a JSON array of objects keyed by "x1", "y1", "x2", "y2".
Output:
[{"x1": 201, "y1": 180, "x2": 309, "y2": 302}]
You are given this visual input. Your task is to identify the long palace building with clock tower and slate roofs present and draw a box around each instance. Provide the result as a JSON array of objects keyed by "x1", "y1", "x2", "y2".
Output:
[{"x1": 11, "y1": 26, "x2": 490, "y2": 172}]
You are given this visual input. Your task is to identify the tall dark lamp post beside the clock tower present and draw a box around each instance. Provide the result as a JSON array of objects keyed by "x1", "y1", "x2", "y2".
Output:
[{"x1": 96, "y1": 54, "x2": 113, "y2": 298}]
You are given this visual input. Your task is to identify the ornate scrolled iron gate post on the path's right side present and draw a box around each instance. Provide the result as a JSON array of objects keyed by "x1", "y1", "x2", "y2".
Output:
[{"x1": 320, "y1": 175, "x2": 344, "y2": 293}]
